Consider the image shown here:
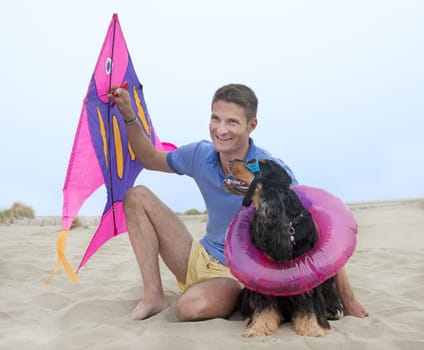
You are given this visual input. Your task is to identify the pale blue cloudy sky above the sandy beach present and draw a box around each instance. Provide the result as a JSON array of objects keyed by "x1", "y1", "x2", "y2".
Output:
[{"x1": 0, "y1": 0, "x2": 424, "y2": 216}]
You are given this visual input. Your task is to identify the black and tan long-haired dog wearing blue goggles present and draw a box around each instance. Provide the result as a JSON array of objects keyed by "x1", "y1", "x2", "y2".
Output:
[{"x1": 224, "y1": 159, "x2": 343, "y2": 337}]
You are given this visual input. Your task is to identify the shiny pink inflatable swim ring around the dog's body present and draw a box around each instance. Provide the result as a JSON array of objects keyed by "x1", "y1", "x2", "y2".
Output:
[{"x1": 224, "y1": 185, "x2": 357, "y2": 296}]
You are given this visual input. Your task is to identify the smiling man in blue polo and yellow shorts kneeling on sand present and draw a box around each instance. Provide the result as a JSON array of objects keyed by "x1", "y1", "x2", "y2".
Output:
[{"x1": 109, "y1": 84, "x2": 367, "y2": 321}]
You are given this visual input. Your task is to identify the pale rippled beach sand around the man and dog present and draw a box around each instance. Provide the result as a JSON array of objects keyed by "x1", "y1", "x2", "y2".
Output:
[{"x1": 0, "y1": 199, "x2": 424, "y2": 350}]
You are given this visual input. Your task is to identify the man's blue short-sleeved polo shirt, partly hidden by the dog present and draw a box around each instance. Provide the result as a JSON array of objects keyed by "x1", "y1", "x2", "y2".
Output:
[{"x1": 167, "y1": 139, "x2": 297, "y2": 265}]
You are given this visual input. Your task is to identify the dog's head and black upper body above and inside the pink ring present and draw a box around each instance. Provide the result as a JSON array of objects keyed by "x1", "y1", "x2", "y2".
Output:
[{"x1": 224, "y1": 159, "x2": 317, "y2": 262}]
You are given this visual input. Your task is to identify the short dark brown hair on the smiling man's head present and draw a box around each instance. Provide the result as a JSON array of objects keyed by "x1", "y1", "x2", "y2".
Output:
[{"x1": 212, "y1": 84, "x2": 258, "y2": 122}]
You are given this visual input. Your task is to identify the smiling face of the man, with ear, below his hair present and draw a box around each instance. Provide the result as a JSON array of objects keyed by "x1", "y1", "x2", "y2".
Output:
[{"x1": 209, "y1": 101, "x2": 256, "y2": 157}]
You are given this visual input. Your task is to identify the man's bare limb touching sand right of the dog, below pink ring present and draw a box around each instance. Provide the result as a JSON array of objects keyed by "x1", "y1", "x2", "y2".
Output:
[{"x1": 335, "y1": 267, "x2": 368, "y2": 318}]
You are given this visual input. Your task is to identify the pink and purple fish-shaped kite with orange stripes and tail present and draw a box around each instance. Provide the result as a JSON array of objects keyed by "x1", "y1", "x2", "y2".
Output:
[{"x1": 45, "y1": 14, "x2": 176, "y2": 283}]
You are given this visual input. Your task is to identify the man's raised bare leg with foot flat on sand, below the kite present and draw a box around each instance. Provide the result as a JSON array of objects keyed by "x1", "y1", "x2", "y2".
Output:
[{"x1": 124, "y1": 186, "x2": 192, "y2": 320}]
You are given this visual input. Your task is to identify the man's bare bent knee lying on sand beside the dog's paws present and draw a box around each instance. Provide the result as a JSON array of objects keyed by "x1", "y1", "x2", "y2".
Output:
[{"x1": 176, "y1": 277, "x2": 241, "y2": 321}]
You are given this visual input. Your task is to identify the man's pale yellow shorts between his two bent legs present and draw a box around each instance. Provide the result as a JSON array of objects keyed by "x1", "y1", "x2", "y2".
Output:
[{"x1": 177, "y1": 240, "x2": 235, "y2": 292}]
